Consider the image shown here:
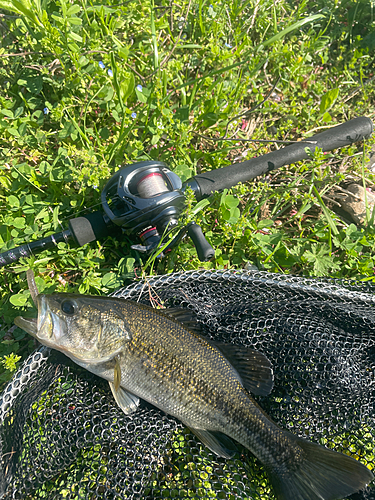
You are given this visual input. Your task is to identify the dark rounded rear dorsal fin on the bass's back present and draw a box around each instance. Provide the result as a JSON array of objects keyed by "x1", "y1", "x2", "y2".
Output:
[{"x1": 209, "y1": 340, "x2": 273, "y2": 396}]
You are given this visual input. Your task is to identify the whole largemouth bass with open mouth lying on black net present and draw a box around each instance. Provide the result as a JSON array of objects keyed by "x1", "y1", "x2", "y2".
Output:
[{"x1": 15, "y1": 275, "x2": 374, "y2": 500}]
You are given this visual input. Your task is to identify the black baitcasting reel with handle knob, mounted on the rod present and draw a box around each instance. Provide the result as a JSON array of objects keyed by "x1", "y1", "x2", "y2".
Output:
[{"x1": 101, "y1": 161, "x2": 214, "y2": 261}]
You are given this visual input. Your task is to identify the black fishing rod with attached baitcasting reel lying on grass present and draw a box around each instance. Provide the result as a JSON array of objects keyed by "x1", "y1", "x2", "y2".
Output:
[{"x1": 0, "y1": 116, "x2": 373, "y2": 267}]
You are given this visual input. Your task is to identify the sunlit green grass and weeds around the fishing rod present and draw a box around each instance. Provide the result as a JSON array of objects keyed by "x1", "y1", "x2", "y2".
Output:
[{"x1": 0, "y1": 0, "x2": 375, "y2": 492}]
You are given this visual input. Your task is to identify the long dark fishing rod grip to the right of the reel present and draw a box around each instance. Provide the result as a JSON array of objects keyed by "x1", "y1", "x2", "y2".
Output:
[{"x1": 192, "y1": 116, "x2": 373, "y2": 200}]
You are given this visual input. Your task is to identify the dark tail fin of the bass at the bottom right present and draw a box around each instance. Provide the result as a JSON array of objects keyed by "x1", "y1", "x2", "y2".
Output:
[{"x1": 270, "y1": 433, "x2": 374, "y2": 500}]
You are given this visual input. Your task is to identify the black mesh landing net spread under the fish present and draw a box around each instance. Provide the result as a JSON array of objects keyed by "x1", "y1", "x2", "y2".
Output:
[{"x1": 0, "y1": 271, "x2": 375, "y2": 500}]
